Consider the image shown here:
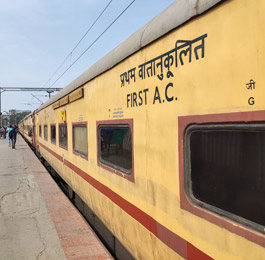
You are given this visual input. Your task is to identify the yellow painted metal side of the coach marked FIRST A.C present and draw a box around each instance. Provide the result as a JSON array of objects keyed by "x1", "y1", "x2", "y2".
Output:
[{"x1": 29, "y1": 0, "x2": 265, "y2": 260}]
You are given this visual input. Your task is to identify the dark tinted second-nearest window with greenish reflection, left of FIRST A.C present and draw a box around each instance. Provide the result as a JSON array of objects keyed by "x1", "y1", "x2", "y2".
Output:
[{"x1": 98, "y1": 125, "x2": 132, "y2": 174}]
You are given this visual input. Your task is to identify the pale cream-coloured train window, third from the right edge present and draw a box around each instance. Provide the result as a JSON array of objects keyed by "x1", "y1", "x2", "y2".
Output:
[{"x1": 73, "y1": 123, "x2": 87, "y2": 156}]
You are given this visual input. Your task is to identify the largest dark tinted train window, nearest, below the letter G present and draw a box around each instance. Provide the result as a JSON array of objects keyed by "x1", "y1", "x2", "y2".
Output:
[{"x1": 185, "y1": 124, "x2": 265, "y2": 228}]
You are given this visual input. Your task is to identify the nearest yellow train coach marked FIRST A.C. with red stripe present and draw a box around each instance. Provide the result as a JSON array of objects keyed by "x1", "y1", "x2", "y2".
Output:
[{"x1": 19, "y1": 0, "x2": 265, "y2": 260}]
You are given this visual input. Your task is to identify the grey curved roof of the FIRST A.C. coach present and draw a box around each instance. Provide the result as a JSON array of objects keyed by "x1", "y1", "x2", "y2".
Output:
[{"x1": 36, "y1": 0, "x2": 223, "y2": 111}]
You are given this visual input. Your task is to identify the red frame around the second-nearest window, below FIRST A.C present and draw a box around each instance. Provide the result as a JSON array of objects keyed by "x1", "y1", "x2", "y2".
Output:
[{"x1": 96, "y1": 119, "x2": 134, "y2": 182}]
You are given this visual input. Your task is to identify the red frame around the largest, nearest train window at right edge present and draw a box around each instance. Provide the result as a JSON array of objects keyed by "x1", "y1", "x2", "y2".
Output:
[{"x1": 178, "y1": 111, "x2": 265, "y2": 246}]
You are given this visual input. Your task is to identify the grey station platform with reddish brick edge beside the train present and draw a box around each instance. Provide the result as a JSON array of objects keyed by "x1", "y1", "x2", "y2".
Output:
[{"x1": 0, "y1": 135, "x2": 113, "y2": 260}]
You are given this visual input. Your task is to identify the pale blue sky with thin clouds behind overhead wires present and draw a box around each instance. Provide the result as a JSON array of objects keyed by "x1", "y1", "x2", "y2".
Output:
[{"x1": 0, "y1": 0, "x2": 174, "y2": 114}]
